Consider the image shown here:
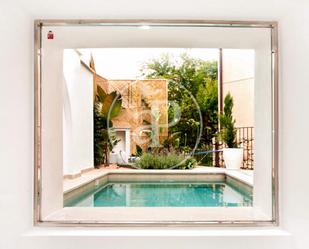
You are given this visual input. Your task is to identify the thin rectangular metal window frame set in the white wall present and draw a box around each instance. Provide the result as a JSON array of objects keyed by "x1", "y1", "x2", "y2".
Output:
[{"x1": 33, "y1": 19, "x2": 279, "y2": 227}]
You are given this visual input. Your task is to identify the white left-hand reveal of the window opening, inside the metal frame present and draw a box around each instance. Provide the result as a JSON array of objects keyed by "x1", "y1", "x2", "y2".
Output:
[{"x1": 41, "y1": 39, "x2": 64, "y2": 217}]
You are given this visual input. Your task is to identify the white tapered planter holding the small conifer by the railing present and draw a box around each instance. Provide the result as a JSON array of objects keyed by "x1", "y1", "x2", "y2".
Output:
[{"x1": 223, "y1": 148, "x2": 244, "y2": 169}]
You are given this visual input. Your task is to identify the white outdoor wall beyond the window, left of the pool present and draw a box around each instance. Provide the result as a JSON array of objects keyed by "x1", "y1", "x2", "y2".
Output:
[{"x1": 61, "y1": 49, "x2": 94, "y2": 174}]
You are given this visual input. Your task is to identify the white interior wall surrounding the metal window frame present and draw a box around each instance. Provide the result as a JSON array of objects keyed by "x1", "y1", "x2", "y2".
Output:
[{"x1": 0, "y1": 0, "x2": 309, "y2": 249}]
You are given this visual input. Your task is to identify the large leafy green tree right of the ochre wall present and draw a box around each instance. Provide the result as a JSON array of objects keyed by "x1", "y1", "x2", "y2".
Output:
[{"x1": 142, "y1": 54, "x2": 218, "y2": 148}]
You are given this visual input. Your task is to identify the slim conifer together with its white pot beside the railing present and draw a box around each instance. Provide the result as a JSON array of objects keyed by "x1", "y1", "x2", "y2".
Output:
[{"x1": 219, "y1": 93, "x2": 243, "y2": 169}]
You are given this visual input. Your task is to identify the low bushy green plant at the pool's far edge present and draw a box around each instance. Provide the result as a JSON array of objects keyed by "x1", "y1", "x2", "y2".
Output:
[{"x1": 136, "y1": 153, "x2": 196, "y2": 169}]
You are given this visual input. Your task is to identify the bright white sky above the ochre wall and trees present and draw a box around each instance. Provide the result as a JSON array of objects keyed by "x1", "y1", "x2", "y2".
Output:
[{"x1": 79, "y1": 48, "x2": 219, "y2": 79}]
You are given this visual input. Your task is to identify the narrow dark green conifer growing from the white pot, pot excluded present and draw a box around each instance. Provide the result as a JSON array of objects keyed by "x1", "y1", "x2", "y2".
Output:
[{"x1": 219, "y1": 93, "x2": 237, "y2": 148}]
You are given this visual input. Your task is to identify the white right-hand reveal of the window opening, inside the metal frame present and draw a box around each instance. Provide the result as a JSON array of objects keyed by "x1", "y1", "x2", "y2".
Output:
[{"x1": 253, "y1": 40, "x2": 272, "y2": 217}]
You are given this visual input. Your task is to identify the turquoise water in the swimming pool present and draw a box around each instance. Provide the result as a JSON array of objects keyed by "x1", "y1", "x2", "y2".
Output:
[{"x1": 64, "y1": 182, "x2": 252, "y2": 207}]
